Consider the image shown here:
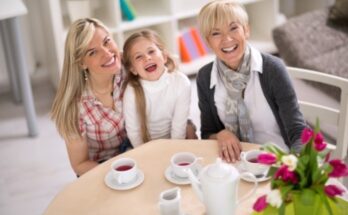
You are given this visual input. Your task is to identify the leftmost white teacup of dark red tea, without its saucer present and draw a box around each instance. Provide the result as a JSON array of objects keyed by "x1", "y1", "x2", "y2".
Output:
[{"x1": 111, "y1": 158, "x2": 138, "y2": 184}]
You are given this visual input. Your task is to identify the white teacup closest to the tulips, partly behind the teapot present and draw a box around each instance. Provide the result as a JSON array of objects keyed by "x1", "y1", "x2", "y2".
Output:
[{"x1": 240, "y1": 150, "x2": 270, "y2": 176}]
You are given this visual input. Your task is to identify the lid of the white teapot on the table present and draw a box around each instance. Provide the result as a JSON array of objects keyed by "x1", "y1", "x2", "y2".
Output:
[{"x1": 207, "y1": 157, "x2": 238, "y2": 179}]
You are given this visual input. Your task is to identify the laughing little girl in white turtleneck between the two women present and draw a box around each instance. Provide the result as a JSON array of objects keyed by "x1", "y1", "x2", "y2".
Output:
[{"x1": 123, "y1": 30, "x2": 191, "y2": 147}]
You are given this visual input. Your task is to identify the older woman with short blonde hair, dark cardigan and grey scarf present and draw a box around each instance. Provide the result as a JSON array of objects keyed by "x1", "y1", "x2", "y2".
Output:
[{"x1": 197, "y1": 0, "x2": 305, "y2": 162}]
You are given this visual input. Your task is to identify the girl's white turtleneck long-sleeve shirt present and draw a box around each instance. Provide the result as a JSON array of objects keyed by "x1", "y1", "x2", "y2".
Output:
[{"x1": 123, "y1": 71, "x2": 191, "y2": 147}]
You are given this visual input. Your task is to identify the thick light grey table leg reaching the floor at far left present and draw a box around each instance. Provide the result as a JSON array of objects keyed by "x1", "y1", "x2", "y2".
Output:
[{"x1": 4, "y1": 17, "x2": 39, "y2": 137}]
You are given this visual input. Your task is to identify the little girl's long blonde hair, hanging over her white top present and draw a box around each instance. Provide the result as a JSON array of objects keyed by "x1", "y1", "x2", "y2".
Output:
[{"x1": 123, "y1": 30, "x2": 176, "y2": 143}]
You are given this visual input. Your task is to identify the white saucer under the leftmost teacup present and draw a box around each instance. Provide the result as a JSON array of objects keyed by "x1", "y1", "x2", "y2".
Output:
[{"x1": 104, "y1": 170, "x2": 144, "y2": 190}]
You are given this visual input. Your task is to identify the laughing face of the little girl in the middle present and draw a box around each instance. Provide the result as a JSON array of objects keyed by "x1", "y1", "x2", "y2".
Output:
[{"x1": 130, "y1": 37, "x2": 167, "y2": 81}]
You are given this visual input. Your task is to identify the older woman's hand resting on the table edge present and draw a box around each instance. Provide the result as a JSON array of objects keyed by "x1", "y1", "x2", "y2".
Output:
[{"x1": 216, "y1": 129, "x2": 242, "y2": 163}]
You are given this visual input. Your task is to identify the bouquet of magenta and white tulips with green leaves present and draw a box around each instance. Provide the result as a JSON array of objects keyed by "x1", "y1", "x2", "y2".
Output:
[{"x1": 253, "y1": 120, "x2": 348, "y2": 215}]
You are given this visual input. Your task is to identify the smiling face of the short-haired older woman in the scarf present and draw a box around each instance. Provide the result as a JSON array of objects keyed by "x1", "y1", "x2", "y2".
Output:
[{"x1": 207, "y1": 22, "x2": 249, "y2": 70}]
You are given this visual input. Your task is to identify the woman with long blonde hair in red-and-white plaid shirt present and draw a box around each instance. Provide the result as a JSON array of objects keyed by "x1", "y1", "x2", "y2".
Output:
[{"x1": 52, "y1": 18, "x2": 126, "y2": 175}]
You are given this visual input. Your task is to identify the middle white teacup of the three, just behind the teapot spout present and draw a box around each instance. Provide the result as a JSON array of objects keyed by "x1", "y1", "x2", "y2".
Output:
[{"x1": 170, "y1": 152, "x2": 198, "y2": 178}]
